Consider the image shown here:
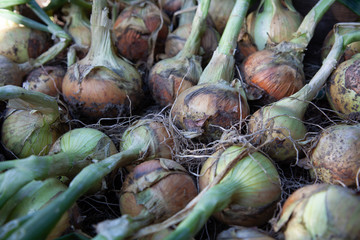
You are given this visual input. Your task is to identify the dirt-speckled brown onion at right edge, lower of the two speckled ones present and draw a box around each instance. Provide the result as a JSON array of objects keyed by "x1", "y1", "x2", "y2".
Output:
[{"x1": 310, "y1": 124, "x2": 360, "y2": 186}]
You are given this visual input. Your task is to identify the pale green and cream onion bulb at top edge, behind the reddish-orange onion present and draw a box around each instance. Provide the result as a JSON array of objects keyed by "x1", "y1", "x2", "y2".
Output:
[{"x1": 247, "y1": 0, "x2": 302, "y2": 50}]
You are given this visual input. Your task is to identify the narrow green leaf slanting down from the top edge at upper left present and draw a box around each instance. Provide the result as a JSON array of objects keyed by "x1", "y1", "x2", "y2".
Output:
[{"x1": 28, "y1": 0, "x2": 71, "y2": 41}]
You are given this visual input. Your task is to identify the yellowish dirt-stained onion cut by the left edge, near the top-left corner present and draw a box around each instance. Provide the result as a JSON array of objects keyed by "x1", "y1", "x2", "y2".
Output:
[{"x1": 0, "y1": 17, "x2": 50, "y2": 63}]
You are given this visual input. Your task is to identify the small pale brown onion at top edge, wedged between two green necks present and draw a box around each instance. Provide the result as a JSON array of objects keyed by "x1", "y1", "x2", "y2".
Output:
[{"x1": 209, "y1": 0, "x2": 236, "y2": 34}]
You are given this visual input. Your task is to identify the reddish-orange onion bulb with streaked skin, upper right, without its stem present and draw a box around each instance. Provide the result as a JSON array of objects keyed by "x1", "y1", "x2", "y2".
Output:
[{"x1": 242, "y1": 49, "x2": 305, "y2": 103}]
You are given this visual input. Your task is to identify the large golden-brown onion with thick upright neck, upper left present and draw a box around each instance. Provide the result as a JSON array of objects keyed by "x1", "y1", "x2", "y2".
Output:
[{"x1": 62, "y1": 0, "x2": 142, "y2": 121}]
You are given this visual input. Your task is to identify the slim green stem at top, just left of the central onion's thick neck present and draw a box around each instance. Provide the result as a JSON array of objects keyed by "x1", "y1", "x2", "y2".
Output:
[{"x1": 179, "y1": 0, "x2": 210, "y2": 58}]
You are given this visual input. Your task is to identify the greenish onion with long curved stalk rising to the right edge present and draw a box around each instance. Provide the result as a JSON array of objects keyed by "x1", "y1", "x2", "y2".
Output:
[{"x1": 248, "y1": 23, "x2": 360, "y2": 162}]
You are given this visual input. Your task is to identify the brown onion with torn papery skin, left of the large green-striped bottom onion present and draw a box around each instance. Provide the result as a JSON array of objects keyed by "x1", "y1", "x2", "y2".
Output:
[{"x1": 120, "y1": 158, "x2": 197, "y2": 222}]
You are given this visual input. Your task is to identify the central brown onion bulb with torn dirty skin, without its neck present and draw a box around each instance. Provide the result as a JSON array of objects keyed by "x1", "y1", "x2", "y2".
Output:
[{"x1": 170, "y1": 83, "x2": 250, "y2": 141}]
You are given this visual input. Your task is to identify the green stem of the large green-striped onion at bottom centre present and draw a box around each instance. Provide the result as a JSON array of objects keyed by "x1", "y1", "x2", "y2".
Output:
[{"x1": 165, "y1": 181, "x2": 237, "y2": 240}]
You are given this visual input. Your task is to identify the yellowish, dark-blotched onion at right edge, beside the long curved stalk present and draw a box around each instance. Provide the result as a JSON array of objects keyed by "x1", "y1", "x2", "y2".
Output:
[{"x1": 325, "y1": 54, "x2": 360, "y2": 120}]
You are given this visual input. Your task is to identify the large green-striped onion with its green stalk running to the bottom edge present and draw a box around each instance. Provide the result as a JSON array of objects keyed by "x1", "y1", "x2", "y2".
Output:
[{"x1": 165, "y1": 146, "x2": 281, "y2": 240}]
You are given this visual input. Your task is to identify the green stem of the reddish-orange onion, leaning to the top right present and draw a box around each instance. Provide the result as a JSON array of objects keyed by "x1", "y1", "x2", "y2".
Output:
[{"x1": 290, "y1": 0, "x2": 335, "y2": 49}]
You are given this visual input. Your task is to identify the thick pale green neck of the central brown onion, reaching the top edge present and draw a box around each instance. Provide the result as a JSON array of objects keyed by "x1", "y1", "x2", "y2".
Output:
[{"x1": 198, "y1": 0, "x2": 250, "y2": 84}]
